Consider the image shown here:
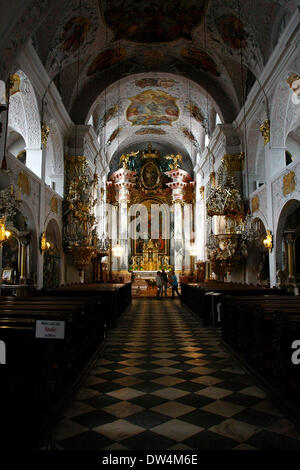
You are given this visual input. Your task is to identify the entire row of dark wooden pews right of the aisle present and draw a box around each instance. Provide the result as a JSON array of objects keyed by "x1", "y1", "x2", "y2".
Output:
[{"x1": 181, "y1": 282, "x2": 300, "y2": 419}]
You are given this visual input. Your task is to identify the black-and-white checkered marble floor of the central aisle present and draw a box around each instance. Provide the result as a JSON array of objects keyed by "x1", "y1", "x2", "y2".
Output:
[{"x1": 52, "y1": 298, "x2": 300, "y2": 450}]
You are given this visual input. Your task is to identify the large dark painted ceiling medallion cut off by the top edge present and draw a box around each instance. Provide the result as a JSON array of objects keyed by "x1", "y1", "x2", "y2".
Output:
[{"x1": 99, "y1": 0, "x2": 207, "y2": 43}]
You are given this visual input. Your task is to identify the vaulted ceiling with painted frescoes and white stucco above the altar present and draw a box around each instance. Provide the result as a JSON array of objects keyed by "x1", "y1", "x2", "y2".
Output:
[{"x1": 12, "y1": 0, "x2": 295, "y2": 165}]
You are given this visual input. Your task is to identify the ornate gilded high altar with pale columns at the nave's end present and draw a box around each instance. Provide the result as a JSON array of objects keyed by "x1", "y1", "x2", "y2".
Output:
[{"x1": 107, "y1": 144, "x2": 195, "y2": 274}]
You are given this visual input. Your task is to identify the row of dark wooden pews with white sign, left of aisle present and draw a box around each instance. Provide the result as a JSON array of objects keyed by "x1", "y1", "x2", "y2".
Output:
[{"x1": 0, "y1": 284, "x2": 131, "y2": 448}]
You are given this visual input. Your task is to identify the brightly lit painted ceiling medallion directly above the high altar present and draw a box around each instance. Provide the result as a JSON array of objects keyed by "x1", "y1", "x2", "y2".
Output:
[{"x1": 126, "y1": 90, "x2": 179, "y2": 126}]
